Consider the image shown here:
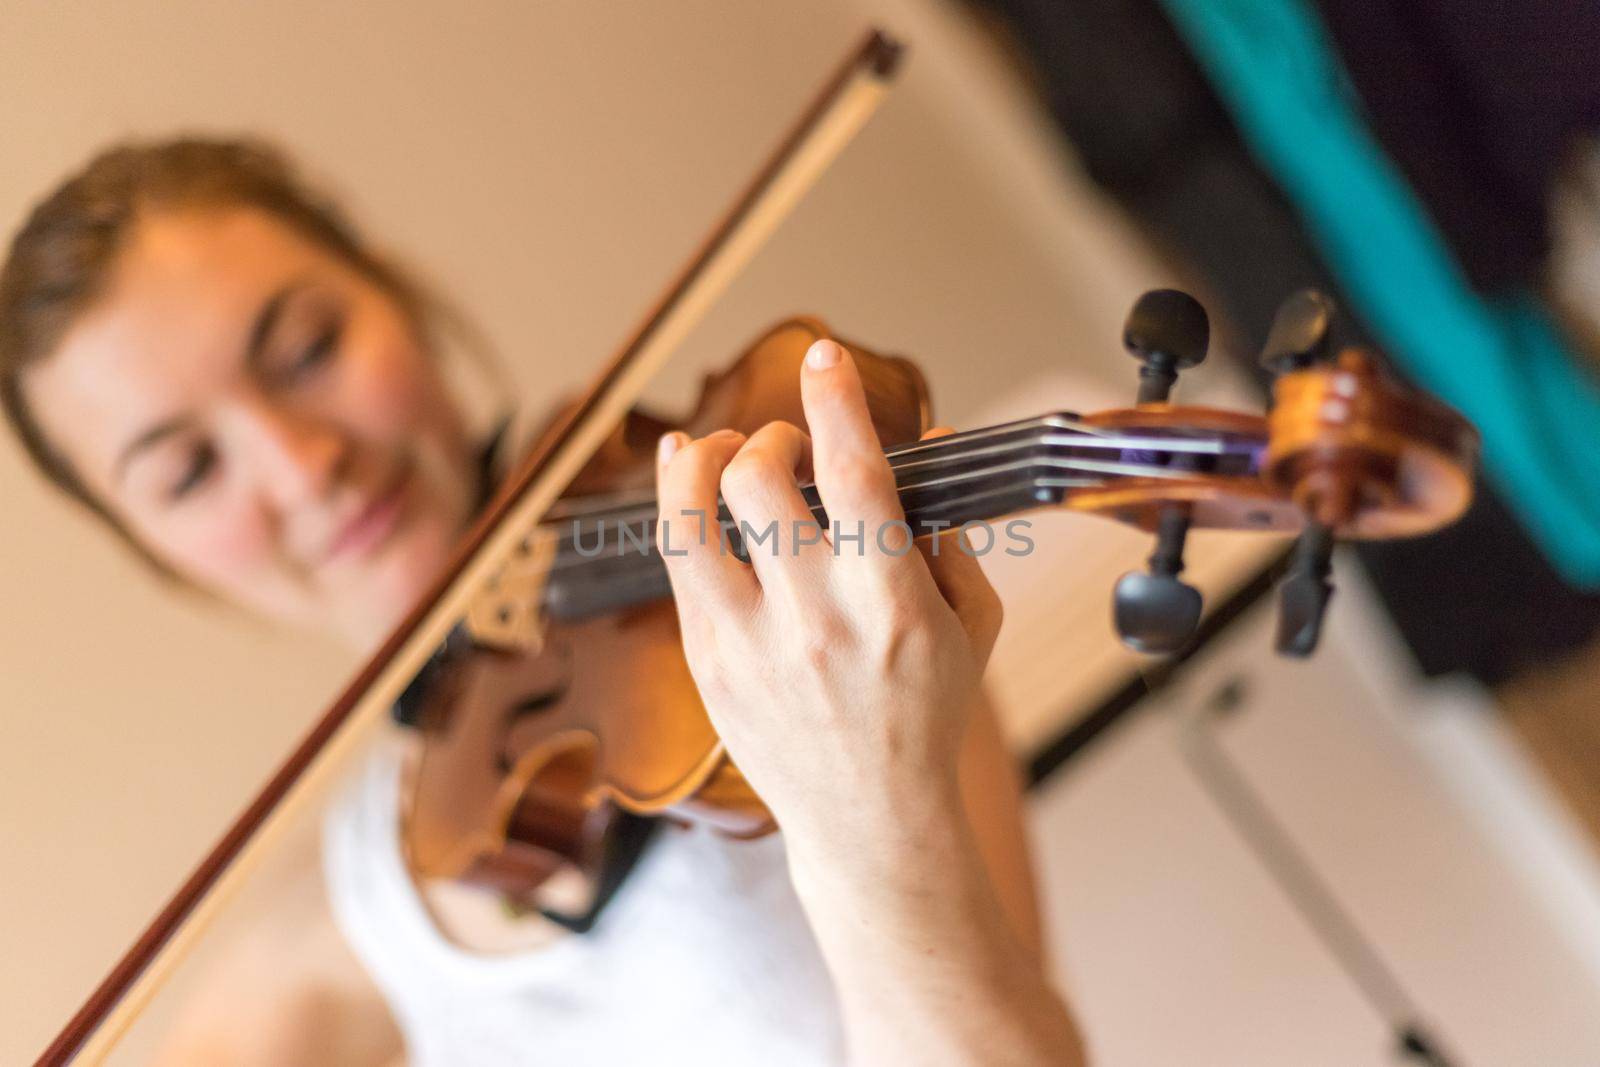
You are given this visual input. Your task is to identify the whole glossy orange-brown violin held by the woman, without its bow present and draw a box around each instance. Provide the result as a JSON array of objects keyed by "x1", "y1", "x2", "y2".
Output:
[{"x1": 395, "y1": 290, "x2": 1477, "y2": 928}]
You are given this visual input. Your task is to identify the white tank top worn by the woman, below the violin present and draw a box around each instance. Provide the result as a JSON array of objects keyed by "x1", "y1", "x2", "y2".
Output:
[{"x1": 323, "y1": 747, "x2": 845, "y2": 1067}]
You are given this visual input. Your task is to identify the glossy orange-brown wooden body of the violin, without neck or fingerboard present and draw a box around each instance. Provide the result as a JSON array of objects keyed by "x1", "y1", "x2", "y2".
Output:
[{"x1": 403, "y1": 318, "x2": 928, "y2": 902}]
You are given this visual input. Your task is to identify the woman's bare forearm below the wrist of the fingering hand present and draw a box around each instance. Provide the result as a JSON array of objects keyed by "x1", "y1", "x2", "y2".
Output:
[{"x1": 789, "y1": 777, "x2": 1083, "y2": 1067}]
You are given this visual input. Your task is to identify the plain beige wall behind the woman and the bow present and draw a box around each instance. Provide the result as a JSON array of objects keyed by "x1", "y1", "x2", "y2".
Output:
[{"x1": 0, "y1": 0, "x2": 1216, "y2": 1062}]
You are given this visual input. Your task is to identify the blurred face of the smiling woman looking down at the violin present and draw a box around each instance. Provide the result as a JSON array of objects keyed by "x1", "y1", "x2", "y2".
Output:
[{"x1": 26, "y1": 210, "x2": 477, "y2": 646}]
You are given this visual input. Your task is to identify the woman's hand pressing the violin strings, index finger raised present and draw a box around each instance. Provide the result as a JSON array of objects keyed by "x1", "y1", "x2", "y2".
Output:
[{"x1": 658, "y1": 341, "x2": 1000, "y2": 859}]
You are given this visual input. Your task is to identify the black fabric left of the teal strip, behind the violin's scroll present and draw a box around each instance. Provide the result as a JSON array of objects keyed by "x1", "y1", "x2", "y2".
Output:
[{"x1": 960, "y1": 0, "x2": 1600, "y2": 683}]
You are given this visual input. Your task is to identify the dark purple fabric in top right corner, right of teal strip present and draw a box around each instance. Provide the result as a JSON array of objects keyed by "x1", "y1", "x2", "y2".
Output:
[{"x1": 1317, "y1": 0, "x2": 1600, "y2": 293}]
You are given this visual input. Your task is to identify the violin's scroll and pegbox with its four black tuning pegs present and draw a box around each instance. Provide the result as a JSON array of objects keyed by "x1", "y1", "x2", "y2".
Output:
[{"x1": 1100, "y1": 290, "x2": 1478, "y2": 656}]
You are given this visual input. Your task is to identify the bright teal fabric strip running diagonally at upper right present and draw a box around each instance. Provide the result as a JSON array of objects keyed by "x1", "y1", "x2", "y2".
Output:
[{"x1": 1162, "y1": 0, "x2": 1600, "y2": 587}]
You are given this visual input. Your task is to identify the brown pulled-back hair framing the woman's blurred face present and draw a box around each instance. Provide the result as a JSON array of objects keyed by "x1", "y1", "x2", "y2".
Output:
[{"x1": 0, "y1": 138, "x2": 470, "y2": 573}]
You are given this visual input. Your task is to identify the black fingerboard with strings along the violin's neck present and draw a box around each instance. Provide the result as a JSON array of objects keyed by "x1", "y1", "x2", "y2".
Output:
[{"x1": 541, "y1": 413, "x2": 1256, "y2": 621}]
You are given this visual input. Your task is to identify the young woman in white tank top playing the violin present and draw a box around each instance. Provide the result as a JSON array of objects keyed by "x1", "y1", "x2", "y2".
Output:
[{"x1": 0, "y1": 141, "x2": 1077, "y2": 1065}]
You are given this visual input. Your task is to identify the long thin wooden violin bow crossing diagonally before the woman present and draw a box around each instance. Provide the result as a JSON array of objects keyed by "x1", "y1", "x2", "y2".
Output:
[{"x1": 35, "y1": 30, "x2": 904, "y2": 1067}]
